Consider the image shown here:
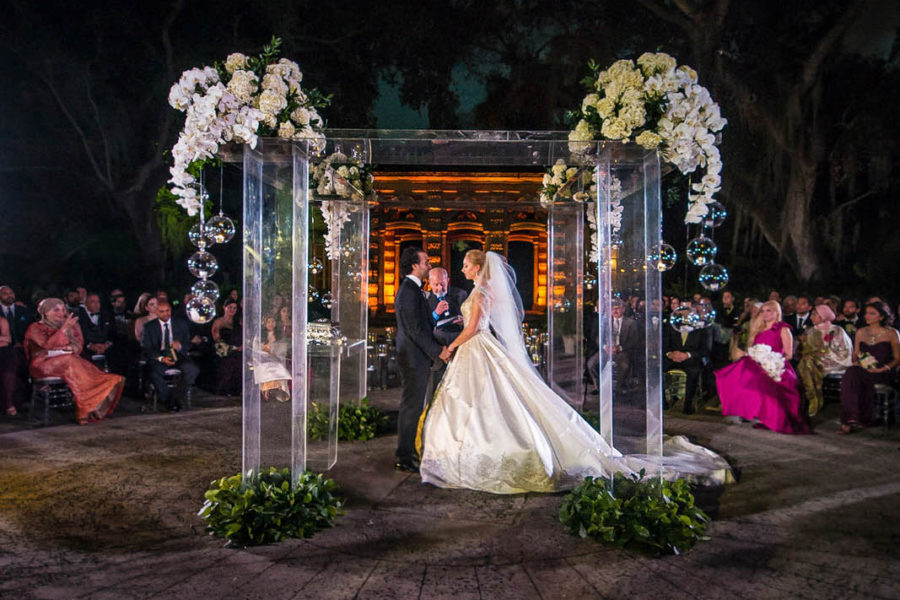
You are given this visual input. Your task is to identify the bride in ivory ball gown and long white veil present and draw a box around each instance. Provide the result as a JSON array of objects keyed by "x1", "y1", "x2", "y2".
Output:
[{"x1": 416, "y1": 250, "x2": 652, "y2": 494}]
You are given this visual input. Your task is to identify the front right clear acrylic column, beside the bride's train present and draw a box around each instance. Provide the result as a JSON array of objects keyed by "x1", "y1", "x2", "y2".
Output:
[{"x1": 597, "y1": 143, "x2": 662, "y2": 474}]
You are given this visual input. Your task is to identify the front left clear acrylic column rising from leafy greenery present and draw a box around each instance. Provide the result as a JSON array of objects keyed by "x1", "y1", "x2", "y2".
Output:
[{"x1": 243, "y1": 138, "x2": 310, "y2": 481}]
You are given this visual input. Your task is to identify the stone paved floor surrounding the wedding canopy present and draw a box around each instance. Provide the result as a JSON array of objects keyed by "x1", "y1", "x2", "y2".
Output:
[{"x1": 0, "y1": 390, "x2": 900, "y2": 600}]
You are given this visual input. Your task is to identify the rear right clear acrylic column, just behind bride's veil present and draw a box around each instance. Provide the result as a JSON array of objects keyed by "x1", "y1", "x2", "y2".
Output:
[{"x1": 547, "y1": 199, "x2": 585, "y2": 409}]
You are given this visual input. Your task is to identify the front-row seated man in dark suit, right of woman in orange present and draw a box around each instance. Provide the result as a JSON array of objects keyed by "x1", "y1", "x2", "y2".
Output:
[{"x1": 141, "y1": 302, "x2": 200, "y2": 412}]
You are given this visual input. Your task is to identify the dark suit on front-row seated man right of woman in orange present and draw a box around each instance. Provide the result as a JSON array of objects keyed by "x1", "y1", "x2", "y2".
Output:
[{"x1": 141, "y1": 319, "x2": 200, "y2": 410}]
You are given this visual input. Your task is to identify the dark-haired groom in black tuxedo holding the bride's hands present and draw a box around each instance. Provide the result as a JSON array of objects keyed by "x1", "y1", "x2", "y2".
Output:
[{"x1": 394, "y1": 247, "x2": 450, "y2": 472}]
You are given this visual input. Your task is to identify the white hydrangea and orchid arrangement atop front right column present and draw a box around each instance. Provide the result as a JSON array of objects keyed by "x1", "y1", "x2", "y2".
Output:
[{"x1": 569, "y1": 52, "x2": 728, "y2": 224}]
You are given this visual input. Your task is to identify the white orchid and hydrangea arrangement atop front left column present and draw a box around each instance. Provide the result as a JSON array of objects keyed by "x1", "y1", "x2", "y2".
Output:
[{"x1": 169, "y1": 38, "x2": 329, "y2": 216}]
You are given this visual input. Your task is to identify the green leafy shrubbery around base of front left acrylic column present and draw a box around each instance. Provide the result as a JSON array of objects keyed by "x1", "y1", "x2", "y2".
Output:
[{"x1": 198, "y1": 467, "x2": 343, "y2": 546}]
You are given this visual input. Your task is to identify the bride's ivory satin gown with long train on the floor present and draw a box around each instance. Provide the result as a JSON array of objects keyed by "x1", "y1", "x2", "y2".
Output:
[{"x1": 417, "y1": 287, "x2": 730, "y2": 494}]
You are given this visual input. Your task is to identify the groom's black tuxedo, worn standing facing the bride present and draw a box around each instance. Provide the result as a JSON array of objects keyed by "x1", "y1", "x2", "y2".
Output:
[{"x1": 394, "y1": 277, "x2": 443, "y2": 461}]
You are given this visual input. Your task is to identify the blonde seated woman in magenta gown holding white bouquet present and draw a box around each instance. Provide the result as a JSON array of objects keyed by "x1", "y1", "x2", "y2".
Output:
[{"x1": 716, "y1": 300, "x2": 810, "y2": 433}]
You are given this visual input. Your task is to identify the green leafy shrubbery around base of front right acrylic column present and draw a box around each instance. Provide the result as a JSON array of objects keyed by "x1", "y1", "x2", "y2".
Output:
[{"x1": 559, "y1": 470, "x2": 709, "y2": 555}]
